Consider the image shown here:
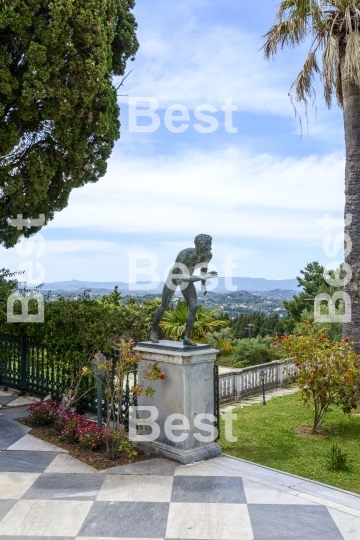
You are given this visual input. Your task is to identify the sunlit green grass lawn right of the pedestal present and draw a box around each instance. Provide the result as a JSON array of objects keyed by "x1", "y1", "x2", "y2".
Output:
[{"x1": 219, "y1": 394, "x2": 360, "y2": 493}]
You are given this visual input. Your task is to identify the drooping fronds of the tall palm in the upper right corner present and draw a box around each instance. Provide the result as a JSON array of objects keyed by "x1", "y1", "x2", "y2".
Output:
[{"x1": 263, "y1": 0, "x2": 360, "y2": 107}]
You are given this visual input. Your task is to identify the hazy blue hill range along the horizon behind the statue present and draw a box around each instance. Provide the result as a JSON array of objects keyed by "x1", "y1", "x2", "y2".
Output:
[{"x1": 38, "y1": 277, "x2": 299, "y2": 294}]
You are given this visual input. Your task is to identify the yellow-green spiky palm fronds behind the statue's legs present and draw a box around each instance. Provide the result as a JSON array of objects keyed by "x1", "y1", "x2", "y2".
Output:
[{"x1": 160, "y1": 300, "x2": 229, "y2": 343}]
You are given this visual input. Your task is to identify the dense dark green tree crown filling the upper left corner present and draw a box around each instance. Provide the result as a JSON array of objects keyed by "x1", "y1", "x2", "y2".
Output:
[{"x1": 0, "y1": 0, "x2": 139, "y2": 247}]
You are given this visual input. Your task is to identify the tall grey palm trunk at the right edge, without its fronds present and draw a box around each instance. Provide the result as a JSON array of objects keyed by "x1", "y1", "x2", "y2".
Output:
[{"x1": 341, "y1": 58, "x2": 360, "y2": 353}]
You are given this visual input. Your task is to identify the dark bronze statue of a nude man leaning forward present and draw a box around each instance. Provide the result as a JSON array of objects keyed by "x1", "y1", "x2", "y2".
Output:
[{"x1": 150, "y1": 234, "x2": 217, "y2": 345}]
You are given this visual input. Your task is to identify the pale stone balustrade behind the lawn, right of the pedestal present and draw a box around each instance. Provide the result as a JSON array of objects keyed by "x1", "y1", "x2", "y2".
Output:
[{"x1": 218, "y1": 360, "x2": 295, "y2": 403}]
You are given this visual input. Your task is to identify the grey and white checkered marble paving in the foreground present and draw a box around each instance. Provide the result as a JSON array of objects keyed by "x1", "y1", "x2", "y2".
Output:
[{"x1": 0, "y1": 394, "x2": 360, "y2": 540}]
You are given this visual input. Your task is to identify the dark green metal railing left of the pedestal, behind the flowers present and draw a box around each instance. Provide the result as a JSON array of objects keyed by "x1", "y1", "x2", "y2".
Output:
[{"x1": 0, "y1": 334, "x2": 138, "y2": 428}]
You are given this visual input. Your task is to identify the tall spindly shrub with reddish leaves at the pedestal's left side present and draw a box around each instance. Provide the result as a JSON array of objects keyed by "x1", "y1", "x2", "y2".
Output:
[{"x1": 95, "y1": 339, "x2": 165, "y2": 459}]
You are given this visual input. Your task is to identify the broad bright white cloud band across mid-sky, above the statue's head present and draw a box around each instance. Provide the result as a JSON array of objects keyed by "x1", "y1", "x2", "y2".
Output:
[{"x1": 49, "y1": 147, "x2": 344, "y2": 239}]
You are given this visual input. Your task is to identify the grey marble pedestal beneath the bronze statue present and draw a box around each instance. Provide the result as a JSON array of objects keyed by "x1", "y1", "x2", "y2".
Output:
[{"x1": 133, "y1": 340, "x2": 221, "y2": 464}]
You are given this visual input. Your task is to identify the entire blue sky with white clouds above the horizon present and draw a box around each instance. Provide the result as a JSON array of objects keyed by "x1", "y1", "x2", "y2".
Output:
[{"x1": 0, "y1": 0, "x2": 344, "y2": 282}]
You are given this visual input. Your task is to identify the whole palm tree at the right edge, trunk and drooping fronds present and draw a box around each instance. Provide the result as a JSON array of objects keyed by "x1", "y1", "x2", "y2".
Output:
[{"x1": 263, "y1": 0, "x2": 360, "y2": 352}]
